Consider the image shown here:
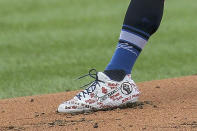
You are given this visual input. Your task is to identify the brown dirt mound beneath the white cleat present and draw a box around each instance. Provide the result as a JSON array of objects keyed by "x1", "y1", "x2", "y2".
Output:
[{"x1": 0, "y1": 75, "x2": 197, "y2": 131}]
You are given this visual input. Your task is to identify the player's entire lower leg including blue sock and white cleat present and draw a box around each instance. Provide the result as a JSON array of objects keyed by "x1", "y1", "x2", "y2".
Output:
[{"x1": 58, "y1": 0, "x2": 163, "y2": 113}]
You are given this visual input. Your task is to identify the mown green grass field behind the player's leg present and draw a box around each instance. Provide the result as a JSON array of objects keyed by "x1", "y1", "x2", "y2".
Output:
[{"x1": 0, "y1": 0, "x2": 197, "y2": 98}]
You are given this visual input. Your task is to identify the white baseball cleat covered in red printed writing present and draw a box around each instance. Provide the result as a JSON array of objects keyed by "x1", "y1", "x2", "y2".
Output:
[{"x1": 58, "y1": 69, "x2": 140, "y2": 113}]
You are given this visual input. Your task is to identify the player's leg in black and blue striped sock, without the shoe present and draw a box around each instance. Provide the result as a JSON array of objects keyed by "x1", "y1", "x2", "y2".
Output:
[{"x1": 104, "y1": 0, "x2": 164, "y2": 81}]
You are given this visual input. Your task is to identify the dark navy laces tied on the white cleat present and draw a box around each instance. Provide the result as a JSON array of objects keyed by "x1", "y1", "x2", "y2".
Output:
[{"x1": 76, "y1": 69, "x2": 104, "y2": 100}]
